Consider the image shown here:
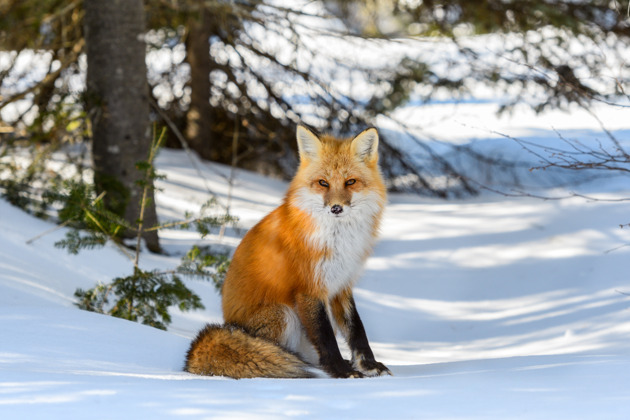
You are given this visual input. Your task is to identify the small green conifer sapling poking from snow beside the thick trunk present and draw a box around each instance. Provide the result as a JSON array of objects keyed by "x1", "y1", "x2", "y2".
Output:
[{"x1": 46, "y1": 127, "x2": 235, "y2": 329}]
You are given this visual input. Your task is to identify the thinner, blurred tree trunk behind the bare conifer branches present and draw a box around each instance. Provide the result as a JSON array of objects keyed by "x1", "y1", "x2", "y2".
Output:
[{"x1": 186, "y1": 10, "x2": 216, "y2": 160}]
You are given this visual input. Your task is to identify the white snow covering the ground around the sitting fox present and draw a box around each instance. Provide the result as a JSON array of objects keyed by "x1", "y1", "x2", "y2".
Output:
[{"x1": 0, "y1": 103, "x2": 630, "y2": 420}]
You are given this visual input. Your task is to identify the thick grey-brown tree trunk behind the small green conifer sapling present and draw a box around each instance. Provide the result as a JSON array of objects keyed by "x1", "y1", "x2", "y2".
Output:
[{"x1": 83, "y1": 0, "x2": 160, "y2": 252}]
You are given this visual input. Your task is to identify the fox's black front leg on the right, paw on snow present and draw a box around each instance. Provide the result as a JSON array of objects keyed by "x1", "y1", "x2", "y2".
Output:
[{"x1": 331, "y1": 291, "x2": 392, "y2": 376}]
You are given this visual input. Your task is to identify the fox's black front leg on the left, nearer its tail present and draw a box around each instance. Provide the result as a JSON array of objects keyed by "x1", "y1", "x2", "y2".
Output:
[{"x1": 297, "y1": 295, "x2": 363, "y2": 378}]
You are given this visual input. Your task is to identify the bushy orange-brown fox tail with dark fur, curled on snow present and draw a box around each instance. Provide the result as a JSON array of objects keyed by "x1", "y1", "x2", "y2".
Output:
[{"x1": 184, "y1": 324, "x2": 318, "y2": 379}]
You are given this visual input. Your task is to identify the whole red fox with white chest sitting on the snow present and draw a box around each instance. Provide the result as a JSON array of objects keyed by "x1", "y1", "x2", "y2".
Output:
[{"x1": 185, "y1": 126, "x2": 391, "y2": 378}]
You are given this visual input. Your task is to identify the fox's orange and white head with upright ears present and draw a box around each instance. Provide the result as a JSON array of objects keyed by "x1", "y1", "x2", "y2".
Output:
[{"x1": 290, "y1": 125, "x2": 386, "y2": 219}]
